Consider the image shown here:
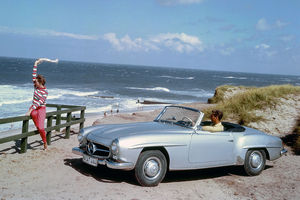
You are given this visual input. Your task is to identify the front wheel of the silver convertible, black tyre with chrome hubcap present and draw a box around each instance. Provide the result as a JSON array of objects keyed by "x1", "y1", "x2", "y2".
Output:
[{"x1": 135, "y1": 150, "x2": 167, "y2": 186}]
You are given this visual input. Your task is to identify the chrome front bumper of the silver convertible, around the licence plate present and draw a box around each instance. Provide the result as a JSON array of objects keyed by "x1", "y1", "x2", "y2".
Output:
[{"x1": 72, "y1": 147, "x2": 134, "y2": 170}]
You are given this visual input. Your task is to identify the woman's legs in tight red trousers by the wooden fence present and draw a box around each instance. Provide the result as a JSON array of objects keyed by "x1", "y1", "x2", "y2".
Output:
[{"x1": 31, "y1": 107, "x2": 47, "y2": 149}]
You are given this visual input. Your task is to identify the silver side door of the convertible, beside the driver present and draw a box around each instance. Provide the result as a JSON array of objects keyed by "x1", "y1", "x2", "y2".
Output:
[{"x1": 189, "y1": 130, "x2": 234, "y2": 167}]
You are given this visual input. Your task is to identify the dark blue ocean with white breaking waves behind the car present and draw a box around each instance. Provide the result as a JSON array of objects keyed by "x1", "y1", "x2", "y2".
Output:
[{"x1": 0, "y1": 57, "x2": 300, "y2": 130}]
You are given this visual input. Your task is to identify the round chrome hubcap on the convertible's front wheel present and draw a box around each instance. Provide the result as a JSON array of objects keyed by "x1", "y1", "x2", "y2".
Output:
[{"x1": 144, "y1": 157, "x2": 161, "y2": 179}]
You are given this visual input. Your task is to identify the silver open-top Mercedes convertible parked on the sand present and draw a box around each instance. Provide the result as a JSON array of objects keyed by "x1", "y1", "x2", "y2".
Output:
[{"x1": 72, "y1": 106, "x2": 287, "y2": 186}]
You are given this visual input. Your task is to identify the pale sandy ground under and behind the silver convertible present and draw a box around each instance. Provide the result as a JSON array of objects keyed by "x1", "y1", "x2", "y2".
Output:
[{"x1": 0, "y1": 103, "x2": 300, "y2": 200}]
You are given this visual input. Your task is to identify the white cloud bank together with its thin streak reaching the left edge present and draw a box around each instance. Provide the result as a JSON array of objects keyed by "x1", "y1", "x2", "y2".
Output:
[{"x1": 0, "y1": 26, "x2": 204, "y2": 53}]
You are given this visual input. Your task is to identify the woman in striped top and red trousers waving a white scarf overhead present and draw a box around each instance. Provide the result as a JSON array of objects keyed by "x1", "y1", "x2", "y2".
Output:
[{"x1": 26, "y1": 58, "x2": 58, "y2": 150}]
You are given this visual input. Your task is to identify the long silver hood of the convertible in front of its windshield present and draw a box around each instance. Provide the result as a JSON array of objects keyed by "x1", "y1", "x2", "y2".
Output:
[{"x1": 87, "y1": 122, "x2": 186, "y2": 139}]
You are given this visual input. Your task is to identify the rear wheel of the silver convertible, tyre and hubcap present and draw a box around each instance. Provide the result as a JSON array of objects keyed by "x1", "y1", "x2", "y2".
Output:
[{"x1": 244, "y1": 149, "x2": 266, "y2": 176}]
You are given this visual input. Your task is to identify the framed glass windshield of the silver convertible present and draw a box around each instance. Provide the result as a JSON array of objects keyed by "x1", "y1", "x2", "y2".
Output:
[{"x1": 155, "y1": 106, "x2": 202, "y2": 127}]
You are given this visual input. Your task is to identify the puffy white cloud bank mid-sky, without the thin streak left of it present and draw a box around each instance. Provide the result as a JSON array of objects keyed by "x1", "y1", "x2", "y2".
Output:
[{"x1": 103, "y1": 33, "x2": 204, "y2": 53}]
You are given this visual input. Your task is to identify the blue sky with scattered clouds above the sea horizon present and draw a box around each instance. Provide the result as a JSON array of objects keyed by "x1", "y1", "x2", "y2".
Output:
[{"x1": 0, "y1": 0, "x2": 300, "y2": 75}]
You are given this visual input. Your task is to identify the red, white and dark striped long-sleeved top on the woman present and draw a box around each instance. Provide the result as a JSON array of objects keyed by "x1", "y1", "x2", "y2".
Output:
[{"x1": 32, "y1": 66, "x2": 48, "y2": 110}]
